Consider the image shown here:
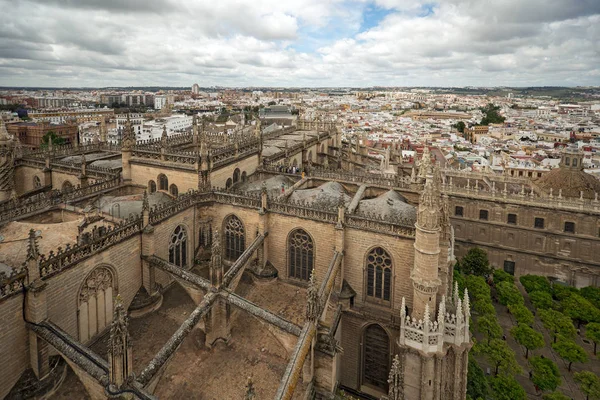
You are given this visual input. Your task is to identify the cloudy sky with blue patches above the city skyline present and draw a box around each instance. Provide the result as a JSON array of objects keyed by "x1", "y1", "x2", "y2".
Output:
[{"x1": 0, "y1": 0, "x2": 600, "y2": 87}]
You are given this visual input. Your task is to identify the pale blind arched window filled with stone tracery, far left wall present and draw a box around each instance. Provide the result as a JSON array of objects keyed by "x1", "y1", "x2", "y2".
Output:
[{"x1": 77, "y1": 266, "x2": 116, "y2": 343}]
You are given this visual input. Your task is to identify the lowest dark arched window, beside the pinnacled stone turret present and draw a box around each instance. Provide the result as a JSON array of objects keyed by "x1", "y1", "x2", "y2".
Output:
[{"x1": 363, "y1": 324, "x2": 390, "y2": 392}]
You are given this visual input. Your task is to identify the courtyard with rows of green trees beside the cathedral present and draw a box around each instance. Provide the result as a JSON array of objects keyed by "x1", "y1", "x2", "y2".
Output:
[{"x1": 454, "y1": 248, "x2": 600, "y2": 400}]
